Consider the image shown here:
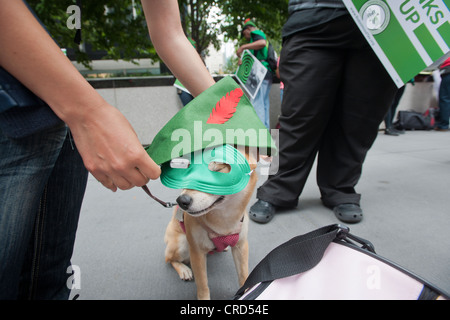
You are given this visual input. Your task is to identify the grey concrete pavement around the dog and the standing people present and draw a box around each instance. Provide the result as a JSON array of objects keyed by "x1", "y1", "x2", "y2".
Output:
[{"x1": 72, "y1": 131, "x2": 450, "y2": 300}]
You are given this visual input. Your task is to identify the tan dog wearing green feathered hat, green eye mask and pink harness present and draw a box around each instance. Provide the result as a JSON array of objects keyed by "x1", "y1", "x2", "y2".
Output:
[{"x1": 144, "y1": 77, "x2": 277, "y2": 299}]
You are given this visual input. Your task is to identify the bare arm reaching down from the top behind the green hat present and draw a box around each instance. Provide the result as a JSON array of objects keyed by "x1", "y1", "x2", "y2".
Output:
[{"x1": 141, "y1": 0, "x2": 214, "y2": 96}]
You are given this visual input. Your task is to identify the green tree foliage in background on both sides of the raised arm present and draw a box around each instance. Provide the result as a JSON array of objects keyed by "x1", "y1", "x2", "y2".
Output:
[{"x1": 27, "y1": 0, "x2": 288, "y2": 66}]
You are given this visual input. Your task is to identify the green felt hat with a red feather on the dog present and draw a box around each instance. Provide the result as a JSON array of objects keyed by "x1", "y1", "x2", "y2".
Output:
[{"x1": 146, "y1": 77, "x2": 276, "y2": 164}]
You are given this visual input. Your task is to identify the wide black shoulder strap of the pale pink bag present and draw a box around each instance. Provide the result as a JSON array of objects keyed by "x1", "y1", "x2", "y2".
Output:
[{"x1": 236, "y1": 224, "x2": 342, "y2": 297}]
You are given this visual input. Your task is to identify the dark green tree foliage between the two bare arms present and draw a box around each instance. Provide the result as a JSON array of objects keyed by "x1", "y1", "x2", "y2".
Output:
[{"x1": 27, "y1": 0, "x2": 157, "y2": 65}]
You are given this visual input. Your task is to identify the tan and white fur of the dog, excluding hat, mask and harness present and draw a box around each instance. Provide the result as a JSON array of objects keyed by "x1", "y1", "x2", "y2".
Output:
[{"x1": 164, "y1": 151, "x2": 258, "y2": 300}]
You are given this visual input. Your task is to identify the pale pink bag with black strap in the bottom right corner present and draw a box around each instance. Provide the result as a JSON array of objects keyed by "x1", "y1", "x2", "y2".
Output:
[{"x1": 235, "y1": 225, "x2": 449, "y2": 300}]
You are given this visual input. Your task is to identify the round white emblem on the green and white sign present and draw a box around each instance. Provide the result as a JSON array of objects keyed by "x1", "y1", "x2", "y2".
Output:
[{"x1": 359, "y1": 0, "x2": 390, "y2": 34}]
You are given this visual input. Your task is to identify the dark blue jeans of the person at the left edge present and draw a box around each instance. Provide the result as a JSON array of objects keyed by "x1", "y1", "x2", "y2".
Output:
[{"x1": 0, "y1": 126, "x2": 87, "y2": 299}]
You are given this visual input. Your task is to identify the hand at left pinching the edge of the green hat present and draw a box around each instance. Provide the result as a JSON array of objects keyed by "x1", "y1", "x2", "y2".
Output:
[{"x1": 68, "y1": 103, "x2": 161, "y2": 191}]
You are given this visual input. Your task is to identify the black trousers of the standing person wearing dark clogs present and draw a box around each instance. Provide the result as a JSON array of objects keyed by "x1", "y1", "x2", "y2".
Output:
[{"x1": 257, "y1": 16, "x2": 396, "y2": 207}]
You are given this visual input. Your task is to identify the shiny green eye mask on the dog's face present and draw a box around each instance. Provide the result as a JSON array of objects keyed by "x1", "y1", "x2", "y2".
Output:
[{"x1": 160, "y1": 145, "x2": 252, "y2": 195}]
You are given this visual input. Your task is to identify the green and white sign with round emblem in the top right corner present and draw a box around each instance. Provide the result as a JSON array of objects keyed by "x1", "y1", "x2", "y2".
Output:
[{"x1": 343, "y1": 0, "x2": 450, "y2": 87}]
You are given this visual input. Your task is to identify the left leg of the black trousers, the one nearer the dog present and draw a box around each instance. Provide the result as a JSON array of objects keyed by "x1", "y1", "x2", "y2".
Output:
[{"x1": 250, "y1": 27, "x2": 343, "y2": 212}]
